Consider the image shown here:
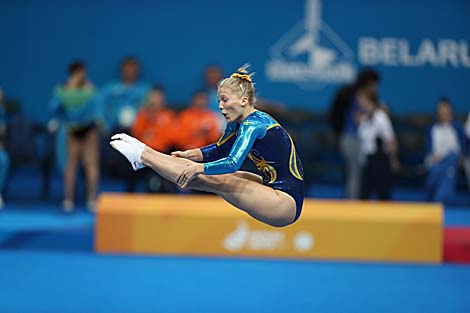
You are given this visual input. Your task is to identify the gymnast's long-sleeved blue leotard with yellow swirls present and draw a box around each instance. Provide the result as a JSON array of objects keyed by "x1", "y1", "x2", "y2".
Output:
[{"x1": 201, "y1": 111, "x2": 304, "y2": 221}]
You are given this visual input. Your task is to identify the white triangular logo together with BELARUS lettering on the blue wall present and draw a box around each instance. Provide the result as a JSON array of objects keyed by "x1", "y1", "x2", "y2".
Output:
[{"x1": 266, "y1": 0, "x2": 470, "y2": 89}]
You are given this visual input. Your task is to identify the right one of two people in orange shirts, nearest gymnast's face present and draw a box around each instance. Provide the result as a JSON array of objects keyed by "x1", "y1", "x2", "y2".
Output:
[{"x1": 176, "y1": 90, "x2": 221, "y2": 150}]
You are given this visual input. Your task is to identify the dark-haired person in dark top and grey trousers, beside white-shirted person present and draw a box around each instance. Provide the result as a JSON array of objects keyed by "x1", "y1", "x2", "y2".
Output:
[{"x1": 329, "y1": 69, "x2": 380, "y2": 199}]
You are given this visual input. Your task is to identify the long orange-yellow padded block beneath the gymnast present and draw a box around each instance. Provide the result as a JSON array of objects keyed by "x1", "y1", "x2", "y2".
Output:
[{"x1": 95, "y1": 193, "x2": 443, "y2": 263}]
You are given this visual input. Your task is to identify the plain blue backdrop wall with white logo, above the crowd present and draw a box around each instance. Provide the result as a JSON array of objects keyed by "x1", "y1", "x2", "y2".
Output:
[{"x1": 0, "y1": 0, "x2": 470, "y2": 120}]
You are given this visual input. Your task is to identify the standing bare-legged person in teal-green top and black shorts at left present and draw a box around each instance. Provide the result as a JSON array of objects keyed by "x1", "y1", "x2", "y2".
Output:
[{"x1": 49, "y1": 61, "x2": 99, "y2": 212}]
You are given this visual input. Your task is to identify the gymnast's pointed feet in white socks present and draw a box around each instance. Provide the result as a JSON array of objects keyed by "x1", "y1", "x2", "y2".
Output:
[{"x1": 109, "y1": 134, "x2": 145, "y2": 171}]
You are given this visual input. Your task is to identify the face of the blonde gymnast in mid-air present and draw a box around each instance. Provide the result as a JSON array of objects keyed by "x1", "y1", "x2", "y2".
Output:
[{"x1": 217, "y1": 87, "x2": 250, "y2": 123}]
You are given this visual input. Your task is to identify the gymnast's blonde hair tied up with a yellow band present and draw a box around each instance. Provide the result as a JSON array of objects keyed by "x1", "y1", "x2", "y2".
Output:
[{"x1": 219, "y1": 64, "x2": 255, "y2": 105}]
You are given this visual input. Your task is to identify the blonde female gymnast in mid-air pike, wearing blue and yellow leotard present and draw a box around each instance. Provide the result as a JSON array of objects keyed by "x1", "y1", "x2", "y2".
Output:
[{"x1": 110, "y1": 65, "x2": 304, "y2": 227}]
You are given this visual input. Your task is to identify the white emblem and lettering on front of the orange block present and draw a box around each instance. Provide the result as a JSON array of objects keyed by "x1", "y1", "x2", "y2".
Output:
[{"x1": 223, "y1": 221, "x2": 314, "y2": 252}]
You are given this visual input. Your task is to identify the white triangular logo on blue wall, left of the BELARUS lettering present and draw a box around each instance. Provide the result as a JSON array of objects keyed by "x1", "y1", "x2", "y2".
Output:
[{"x1": 266, "y1": 0, "x2": 356, "y2": 89}]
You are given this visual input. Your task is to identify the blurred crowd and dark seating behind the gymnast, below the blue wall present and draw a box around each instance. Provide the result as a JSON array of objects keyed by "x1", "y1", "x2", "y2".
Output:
[{"x1": 0, "y1": 56, "x2": 470, "y2": 212}]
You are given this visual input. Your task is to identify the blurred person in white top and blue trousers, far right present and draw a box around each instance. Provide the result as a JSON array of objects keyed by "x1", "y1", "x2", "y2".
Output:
[{"x1": 425, "y1": 98, "x2": 467, "y2": 203}]
